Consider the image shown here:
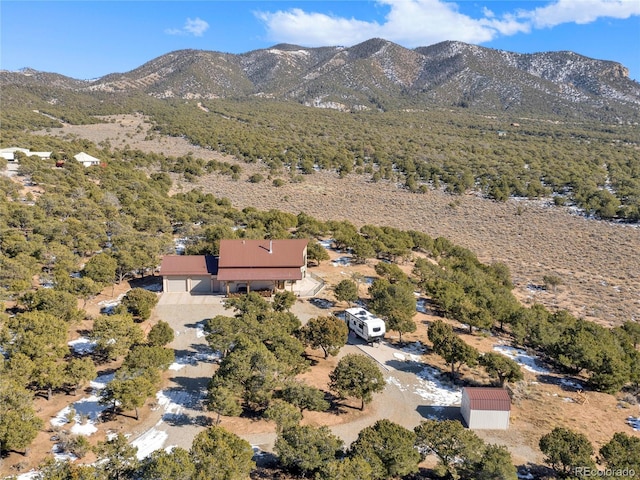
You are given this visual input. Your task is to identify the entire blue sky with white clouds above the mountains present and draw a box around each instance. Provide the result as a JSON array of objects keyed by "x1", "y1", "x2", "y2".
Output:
[{"x1": 0, "y1": 0, "x2": 640, "y2": 81}]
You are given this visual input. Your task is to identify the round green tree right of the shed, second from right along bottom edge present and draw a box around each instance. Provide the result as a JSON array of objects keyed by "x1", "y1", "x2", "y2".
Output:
[{"x1": 539, "y1": 427, "x2": 595, "y2": 477}]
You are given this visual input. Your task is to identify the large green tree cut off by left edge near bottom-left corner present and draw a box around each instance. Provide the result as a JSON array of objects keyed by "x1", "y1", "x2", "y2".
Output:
[{"x1": 0, "y1": 375, "x2": 44, "y2": 455}]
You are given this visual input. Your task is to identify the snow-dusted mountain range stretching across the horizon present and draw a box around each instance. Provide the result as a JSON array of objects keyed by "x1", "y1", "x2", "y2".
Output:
[{"x1": 0, "y1": 38, "x2": 640, "y2": 123}]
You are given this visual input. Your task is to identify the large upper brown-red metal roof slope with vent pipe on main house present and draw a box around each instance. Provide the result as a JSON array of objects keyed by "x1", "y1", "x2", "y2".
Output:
[{"x1": 220, "y1": 239, "x2": 308, "y2": 268}]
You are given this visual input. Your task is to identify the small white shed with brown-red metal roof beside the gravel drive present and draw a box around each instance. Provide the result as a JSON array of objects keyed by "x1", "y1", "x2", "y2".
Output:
[{"x1": 460, "y1": 387, "x2": 511, "y2": 430}]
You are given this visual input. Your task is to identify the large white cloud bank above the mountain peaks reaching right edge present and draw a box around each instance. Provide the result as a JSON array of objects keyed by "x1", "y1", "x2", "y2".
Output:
[{"x1": 255, "y1": 0, "x2": 640, "y2": 48}]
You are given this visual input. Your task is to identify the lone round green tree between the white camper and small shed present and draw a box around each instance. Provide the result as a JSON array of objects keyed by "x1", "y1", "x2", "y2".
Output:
[{"x1": 329, "y1": 353, "x2": 385, "y2": 410}]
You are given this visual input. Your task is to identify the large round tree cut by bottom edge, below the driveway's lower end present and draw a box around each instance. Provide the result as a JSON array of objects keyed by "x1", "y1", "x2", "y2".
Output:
[{"x1": 191, "y1": 426, "x2": 255, "y2": 480}]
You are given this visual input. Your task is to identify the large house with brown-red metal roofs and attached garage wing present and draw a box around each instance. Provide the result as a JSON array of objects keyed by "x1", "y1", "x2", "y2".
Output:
[{"x1": 160, "y1": 239, "x2": 308, "y2": 295}]
